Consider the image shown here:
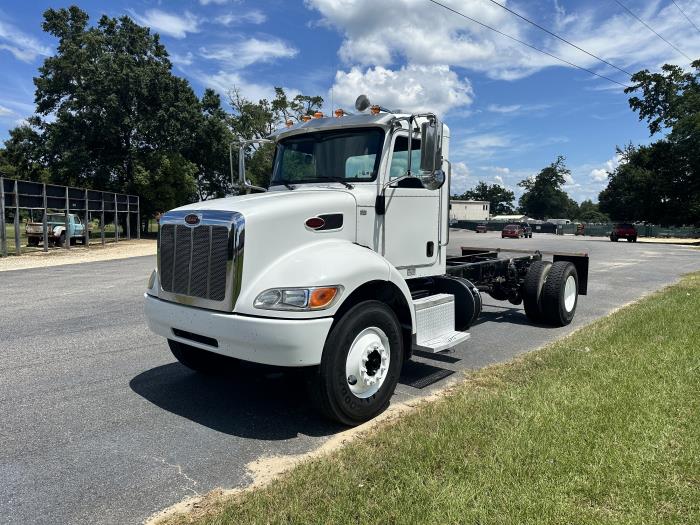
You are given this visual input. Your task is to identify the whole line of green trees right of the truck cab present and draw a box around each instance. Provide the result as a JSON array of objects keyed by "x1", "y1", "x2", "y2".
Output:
[{"x1": 454, "y1": 60, "x2": 700, "y2": 225}]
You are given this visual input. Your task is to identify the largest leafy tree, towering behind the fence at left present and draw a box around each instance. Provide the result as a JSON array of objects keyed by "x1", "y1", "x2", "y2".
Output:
[{"x1": 6, "y1": 6, "x2": 201, "y2": 227}]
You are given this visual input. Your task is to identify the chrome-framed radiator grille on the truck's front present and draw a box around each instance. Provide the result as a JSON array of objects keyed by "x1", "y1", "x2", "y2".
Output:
[{"x1": 158, "y1": 210, "x2": 245, "y2": 311}]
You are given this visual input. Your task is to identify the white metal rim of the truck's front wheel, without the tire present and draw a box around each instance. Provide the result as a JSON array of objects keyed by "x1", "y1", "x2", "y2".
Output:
[{"x1": 345, "y1": 326, "x2": 391, "y2": 399}]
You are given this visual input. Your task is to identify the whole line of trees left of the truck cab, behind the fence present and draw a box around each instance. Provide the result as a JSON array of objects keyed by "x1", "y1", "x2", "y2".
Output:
[{"x1": 0, "y1": 6, "x2": 323, "y2": 228}]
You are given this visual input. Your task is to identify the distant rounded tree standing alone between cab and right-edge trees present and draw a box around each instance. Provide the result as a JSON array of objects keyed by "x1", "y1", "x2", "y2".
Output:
[{"x1": 518, "y1": 155, "x2": 578, "y2": 219}]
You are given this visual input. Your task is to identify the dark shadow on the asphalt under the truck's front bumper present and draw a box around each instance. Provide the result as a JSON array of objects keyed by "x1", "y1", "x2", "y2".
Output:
[{"x1": 129, "y1": 363, "x2": 345, "y2": 441}]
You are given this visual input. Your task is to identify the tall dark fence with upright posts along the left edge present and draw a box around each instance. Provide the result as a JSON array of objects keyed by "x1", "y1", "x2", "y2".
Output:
[{"x1": 0, "y1": 177, "x2": 141, "y2": 257}]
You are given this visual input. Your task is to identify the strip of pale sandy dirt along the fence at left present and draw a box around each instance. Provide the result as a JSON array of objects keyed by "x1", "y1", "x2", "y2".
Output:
[{"x1": 0, "y1": 239, "x2": 156, "y2": 272}]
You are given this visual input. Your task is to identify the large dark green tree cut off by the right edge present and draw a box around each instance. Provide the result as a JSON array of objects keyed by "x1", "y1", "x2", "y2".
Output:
[{"x1": 599, "y1": 60, "x2": 700, "y2": 224}]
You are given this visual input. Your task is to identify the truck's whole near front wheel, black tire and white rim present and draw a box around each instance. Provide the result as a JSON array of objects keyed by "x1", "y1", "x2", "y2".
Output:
[{"x1": 309, "y1": 301, "x2": 404, "y2": 426}]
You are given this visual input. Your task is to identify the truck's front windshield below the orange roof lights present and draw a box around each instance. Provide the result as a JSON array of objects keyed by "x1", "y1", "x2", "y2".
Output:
[{"x1": 271, "y1": 128, "x2": 384, "y2": 185}]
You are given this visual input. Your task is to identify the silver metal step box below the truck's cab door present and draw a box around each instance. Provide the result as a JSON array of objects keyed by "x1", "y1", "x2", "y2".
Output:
[{"x1": 413, "y1": 293, "x2": 469, "y2": 352}]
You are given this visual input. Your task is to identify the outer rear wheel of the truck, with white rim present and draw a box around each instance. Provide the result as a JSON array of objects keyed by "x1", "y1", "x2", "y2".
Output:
[{"x1": 541, "y1": 261, "x2": 578, "y2": 326}]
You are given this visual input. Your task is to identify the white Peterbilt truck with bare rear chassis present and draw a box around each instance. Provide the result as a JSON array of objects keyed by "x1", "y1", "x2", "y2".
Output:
[{"x1": 145, "y1": 96, "x2": 588, "y2": 425}]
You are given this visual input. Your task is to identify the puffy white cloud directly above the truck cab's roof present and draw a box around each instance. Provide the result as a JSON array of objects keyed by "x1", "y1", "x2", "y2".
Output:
[{"x1": 333, "y1": 65, "x2": 474, "y2": 115}]
